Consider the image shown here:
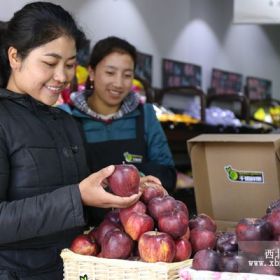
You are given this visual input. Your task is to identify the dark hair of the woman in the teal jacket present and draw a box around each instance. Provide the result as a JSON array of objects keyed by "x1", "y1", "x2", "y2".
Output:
[{"x1": 89, "y1": 36, "x2": 137, "y2": 68}]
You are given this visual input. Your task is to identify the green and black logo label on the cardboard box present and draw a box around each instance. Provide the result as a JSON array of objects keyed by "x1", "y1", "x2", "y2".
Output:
[{"x1": 224, "y1": 165, "x2": 264, "y2": 184}]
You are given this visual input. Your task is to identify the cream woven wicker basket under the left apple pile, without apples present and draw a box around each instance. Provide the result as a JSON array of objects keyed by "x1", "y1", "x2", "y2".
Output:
[{"x1": 61, "y1": 249, "x2": 192, "y2": 280}]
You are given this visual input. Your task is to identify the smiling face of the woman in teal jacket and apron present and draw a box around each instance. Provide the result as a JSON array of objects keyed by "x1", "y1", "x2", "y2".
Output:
[{"x1": 88, "y1": 52, "x2": 134, "y2": 115}]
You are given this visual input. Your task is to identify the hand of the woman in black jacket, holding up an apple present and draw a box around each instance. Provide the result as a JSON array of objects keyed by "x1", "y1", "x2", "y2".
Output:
[{"x1": 79, "y1": 165, "x2": 142, "y2": 208}]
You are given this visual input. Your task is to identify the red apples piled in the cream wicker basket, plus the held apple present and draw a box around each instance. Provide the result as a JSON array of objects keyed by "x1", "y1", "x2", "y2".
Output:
[{"x1": 70, "y1": 164, "x2": 192, "y2": 263}]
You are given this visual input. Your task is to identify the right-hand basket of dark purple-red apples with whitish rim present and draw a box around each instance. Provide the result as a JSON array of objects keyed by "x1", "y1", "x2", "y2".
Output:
[{"x1": 179, "y1": 200, "x2": 280, "y2": 280}]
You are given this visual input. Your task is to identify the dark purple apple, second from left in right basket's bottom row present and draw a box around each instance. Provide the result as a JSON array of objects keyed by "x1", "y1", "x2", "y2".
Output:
[{"x1": 218, "y1": 252, "x2": 250, "y2": 272}]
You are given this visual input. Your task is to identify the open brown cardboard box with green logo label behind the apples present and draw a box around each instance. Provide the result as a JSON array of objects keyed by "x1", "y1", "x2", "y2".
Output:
[{"x1": 187, "y1": 134, "x2": 280, "y2": 224}]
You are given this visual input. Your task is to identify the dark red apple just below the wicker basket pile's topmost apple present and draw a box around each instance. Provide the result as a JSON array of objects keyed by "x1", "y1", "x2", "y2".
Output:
[{"x1": 148, "y1": 195, "x2": 176, "y2": 220}]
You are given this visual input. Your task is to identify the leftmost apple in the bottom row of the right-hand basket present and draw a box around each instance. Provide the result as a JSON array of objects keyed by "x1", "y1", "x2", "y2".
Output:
[{"x1": 192, "y1": 249, "x2": 220, "y2": 271}]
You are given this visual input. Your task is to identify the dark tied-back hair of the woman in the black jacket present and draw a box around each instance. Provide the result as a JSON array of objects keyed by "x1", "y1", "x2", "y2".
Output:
[{"x1": 0, "y1": 2, "x2": 86, "y2": 87}]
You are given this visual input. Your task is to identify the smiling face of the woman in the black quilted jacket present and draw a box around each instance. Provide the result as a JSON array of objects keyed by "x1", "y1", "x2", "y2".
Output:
[{"x1": 7, "y1": 36, "x2": 76, "y2": 105}]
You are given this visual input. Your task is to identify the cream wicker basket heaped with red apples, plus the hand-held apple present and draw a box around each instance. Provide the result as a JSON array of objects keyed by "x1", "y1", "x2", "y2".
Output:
[{"x1": 61, "y1": 164, "x2": 192, "y2": 280}]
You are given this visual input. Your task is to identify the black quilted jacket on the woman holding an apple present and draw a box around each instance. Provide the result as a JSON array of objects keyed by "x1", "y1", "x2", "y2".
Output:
[{"x1": 0, "y1": 89, "x2": 88, "y2": 271}]
